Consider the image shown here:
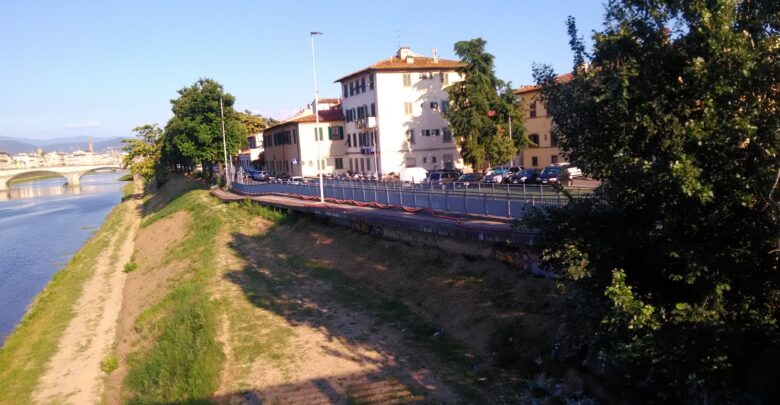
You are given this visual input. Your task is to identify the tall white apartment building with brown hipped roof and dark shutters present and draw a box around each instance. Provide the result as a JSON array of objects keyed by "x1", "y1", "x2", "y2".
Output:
[{"x1": 336, "y1": 47, "x2": 463, "y2": 175}]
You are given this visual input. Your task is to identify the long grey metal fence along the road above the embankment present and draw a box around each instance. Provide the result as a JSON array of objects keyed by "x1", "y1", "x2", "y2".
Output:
[{"x1": 233, "y1": 180, "x2": 592, "y2": 218}]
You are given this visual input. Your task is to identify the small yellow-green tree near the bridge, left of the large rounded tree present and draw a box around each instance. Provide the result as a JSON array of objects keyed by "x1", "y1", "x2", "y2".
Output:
[{"x1": 122, "y1": 124, "x2": 163, "y2": 181}]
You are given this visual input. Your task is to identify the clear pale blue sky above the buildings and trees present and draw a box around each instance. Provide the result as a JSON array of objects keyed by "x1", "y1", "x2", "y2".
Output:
[{"x1": 0, "y1": 0, "x2": 604, "y2": 139}]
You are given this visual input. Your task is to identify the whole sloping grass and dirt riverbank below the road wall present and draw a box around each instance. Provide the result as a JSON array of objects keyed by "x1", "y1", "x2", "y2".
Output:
[{"x1": 0, "y1": 176, "x2": 582, "y2": 404}]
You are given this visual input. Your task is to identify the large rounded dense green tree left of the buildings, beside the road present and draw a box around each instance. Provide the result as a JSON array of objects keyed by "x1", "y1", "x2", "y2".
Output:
[{"x1": 164, "y1": 79, "x2": 246, "y2": 174}]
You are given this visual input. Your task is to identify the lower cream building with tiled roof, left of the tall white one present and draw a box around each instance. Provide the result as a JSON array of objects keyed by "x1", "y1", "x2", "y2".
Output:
[{"x1": 262, "y1": 98, "x2": 347, "y2": 177}]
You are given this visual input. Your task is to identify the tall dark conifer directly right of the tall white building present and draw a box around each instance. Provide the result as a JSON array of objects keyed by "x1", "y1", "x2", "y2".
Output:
[{"x1": 444, "y1": 38, "x2": 528, "y2": 169}]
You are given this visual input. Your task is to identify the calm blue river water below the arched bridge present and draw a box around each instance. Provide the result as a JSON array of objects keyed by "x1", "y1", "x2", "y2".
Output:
[{"x1": 0, "y1": 172, "x2": 126, "y2": 345}]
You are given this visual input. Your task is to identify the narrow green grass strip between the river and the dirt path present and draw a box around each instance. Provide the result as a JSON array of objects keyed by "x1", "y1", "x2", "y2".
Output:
[{"x1": 0, "y1": 183, "x2": 132, "y2": 404}]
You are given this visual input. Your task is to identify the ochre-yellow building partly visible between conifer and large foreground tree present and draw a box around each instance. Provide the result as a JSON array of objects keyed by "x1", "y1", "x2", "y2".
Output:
[{"x1": 515, "y1": 73, "x2": 572, "y2": 168}]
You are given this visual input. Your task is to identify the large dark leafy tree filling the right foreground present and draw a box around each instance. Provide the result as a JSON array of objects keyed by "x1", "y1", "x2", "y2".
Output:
[{"x1": 529, "y1": 0, "x2": 780, "y2": 402}]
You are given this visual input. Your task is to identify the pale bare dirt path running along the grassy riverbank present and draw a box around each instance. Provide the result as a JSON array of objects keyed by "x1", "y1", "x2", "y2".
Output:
[{"x1": 33, "y1": 184, "x2": 140, "y2": 404}]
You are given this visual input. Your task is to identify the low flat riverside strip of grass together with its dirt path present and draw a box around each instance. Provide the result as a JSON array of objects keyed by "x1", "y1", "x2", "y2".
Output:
[{"x1": 0, "y1": 175, "x2": 136, "y2": 403}]
